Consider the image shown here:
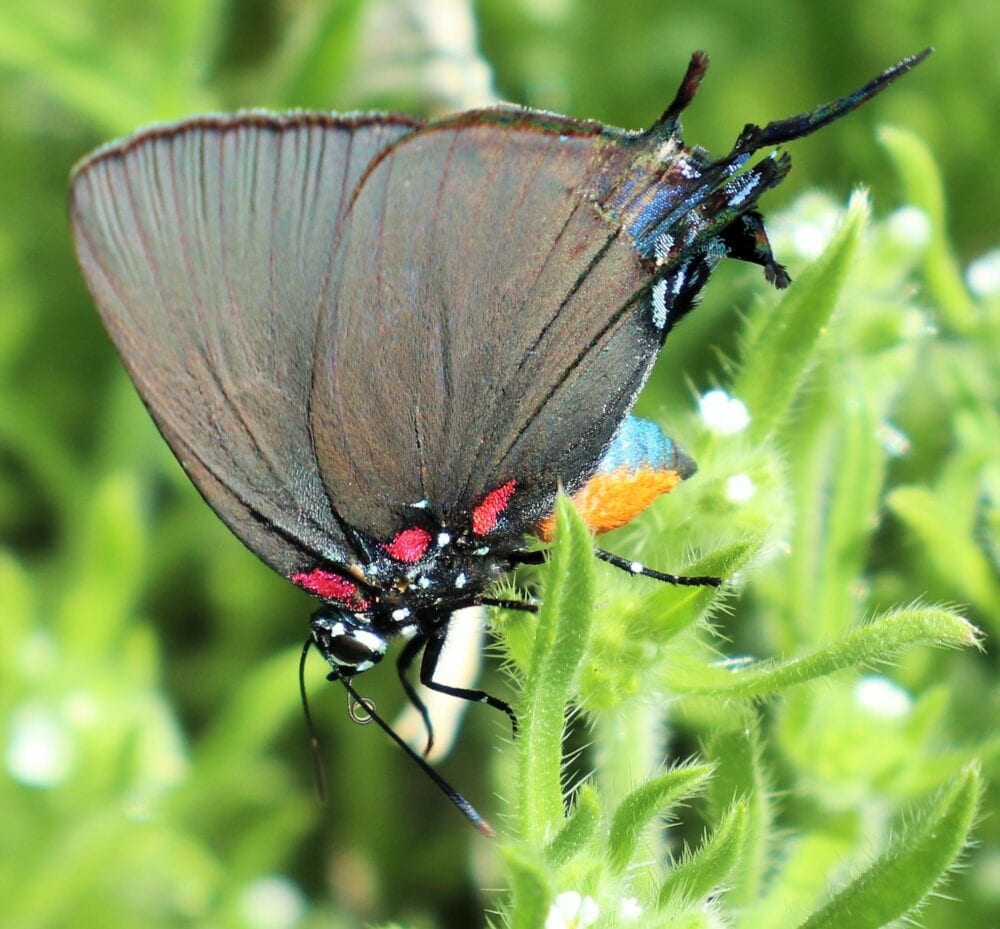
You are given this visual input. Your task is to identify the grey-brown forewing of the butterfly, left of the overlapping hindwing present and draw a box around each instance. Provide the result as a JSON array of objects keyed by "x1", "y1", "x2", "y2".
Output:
[{"x1": 70, "y1": 113, "x2": 416, "y2": 576}]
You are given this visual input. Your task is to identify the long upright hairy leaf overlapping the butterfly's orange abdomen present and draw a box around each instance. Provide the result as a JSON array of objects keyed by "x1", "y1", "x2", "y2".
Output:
[{"x1": 517, "y1": 495, "x2": 594, "y2": 843}]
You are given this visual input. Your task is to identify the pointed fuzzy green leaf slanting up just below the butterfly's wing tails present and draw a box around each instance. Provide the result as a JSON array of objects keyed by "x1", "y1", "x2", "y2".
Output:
[{"x1": 731, "y1": 194, "x2": 868, "y2": 441}]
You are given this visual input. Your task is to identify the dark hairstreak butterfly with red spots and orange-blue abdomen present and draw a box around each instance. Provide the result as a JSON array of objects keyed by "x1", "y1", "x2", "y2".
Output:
[{"x1": 70, "y1": 52, "x2": 927, "y2": 830}]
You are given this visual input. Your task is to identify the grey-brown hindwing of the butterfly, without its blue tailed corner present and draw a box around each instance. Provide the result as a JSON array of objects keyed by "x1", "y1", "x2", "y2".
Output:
[{"x1": 311, "y1": 110, "x2": 663, "y2": 539}]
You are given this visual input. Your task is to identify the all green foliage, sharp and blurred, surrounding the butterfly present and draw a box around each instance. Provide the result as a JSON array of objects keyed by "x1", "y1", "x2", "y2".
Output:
[{"x1": 0, "y1": 0, "x2": 1000, "y2": 929}]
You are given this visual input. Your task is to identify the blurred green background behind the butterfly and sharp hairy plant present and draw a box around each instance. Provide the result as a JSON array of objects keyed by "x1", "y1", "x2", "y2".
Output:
[{"x1": 0, "y1": 0, "x2": 1000, "y2": 929}]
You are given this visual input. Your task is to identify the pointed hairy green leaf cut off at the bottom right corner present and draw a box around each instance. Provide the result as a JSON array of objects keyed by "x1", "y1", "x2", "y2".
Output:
[{"x1": 800, "y1": 764, "x2": 980, "y2": 929}]
